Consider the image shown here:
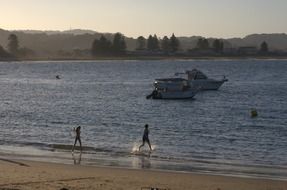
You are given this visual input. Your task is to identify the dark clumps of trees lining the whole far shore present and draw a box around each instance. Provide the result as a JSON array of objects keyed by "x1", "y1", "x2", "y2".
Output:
[{"x1": 0, "y1": 32, "x2": 269, "y2": 58}]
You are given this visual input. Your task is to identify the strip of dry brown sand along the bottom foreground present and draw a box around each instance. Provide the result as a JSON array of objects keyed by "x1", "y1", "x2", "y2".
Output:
[{"x1": 0, "y1": 159, "x2": 287, "y2": 190}]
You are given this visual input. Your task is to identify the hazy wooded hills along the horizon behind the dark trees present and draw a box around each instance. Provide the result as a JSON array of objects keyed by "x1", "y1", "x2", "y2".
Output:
[{"x1": 0, "y1": 29, "x2": 287, "y2": 56}]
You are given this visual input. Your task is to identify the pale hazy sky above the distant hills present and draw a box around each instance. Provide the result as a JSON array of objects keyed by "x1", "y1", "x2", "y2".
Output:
[{"x1": 0, "y1": 0, "x2": 287, "y2": 38}]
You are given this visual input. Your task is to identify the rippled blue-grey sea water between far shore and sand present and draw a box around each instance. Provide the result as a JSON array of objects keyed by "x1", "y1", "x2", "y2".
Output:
[{"x1": 0, "y1": 60, "x2": 287, "y2": 179}]
